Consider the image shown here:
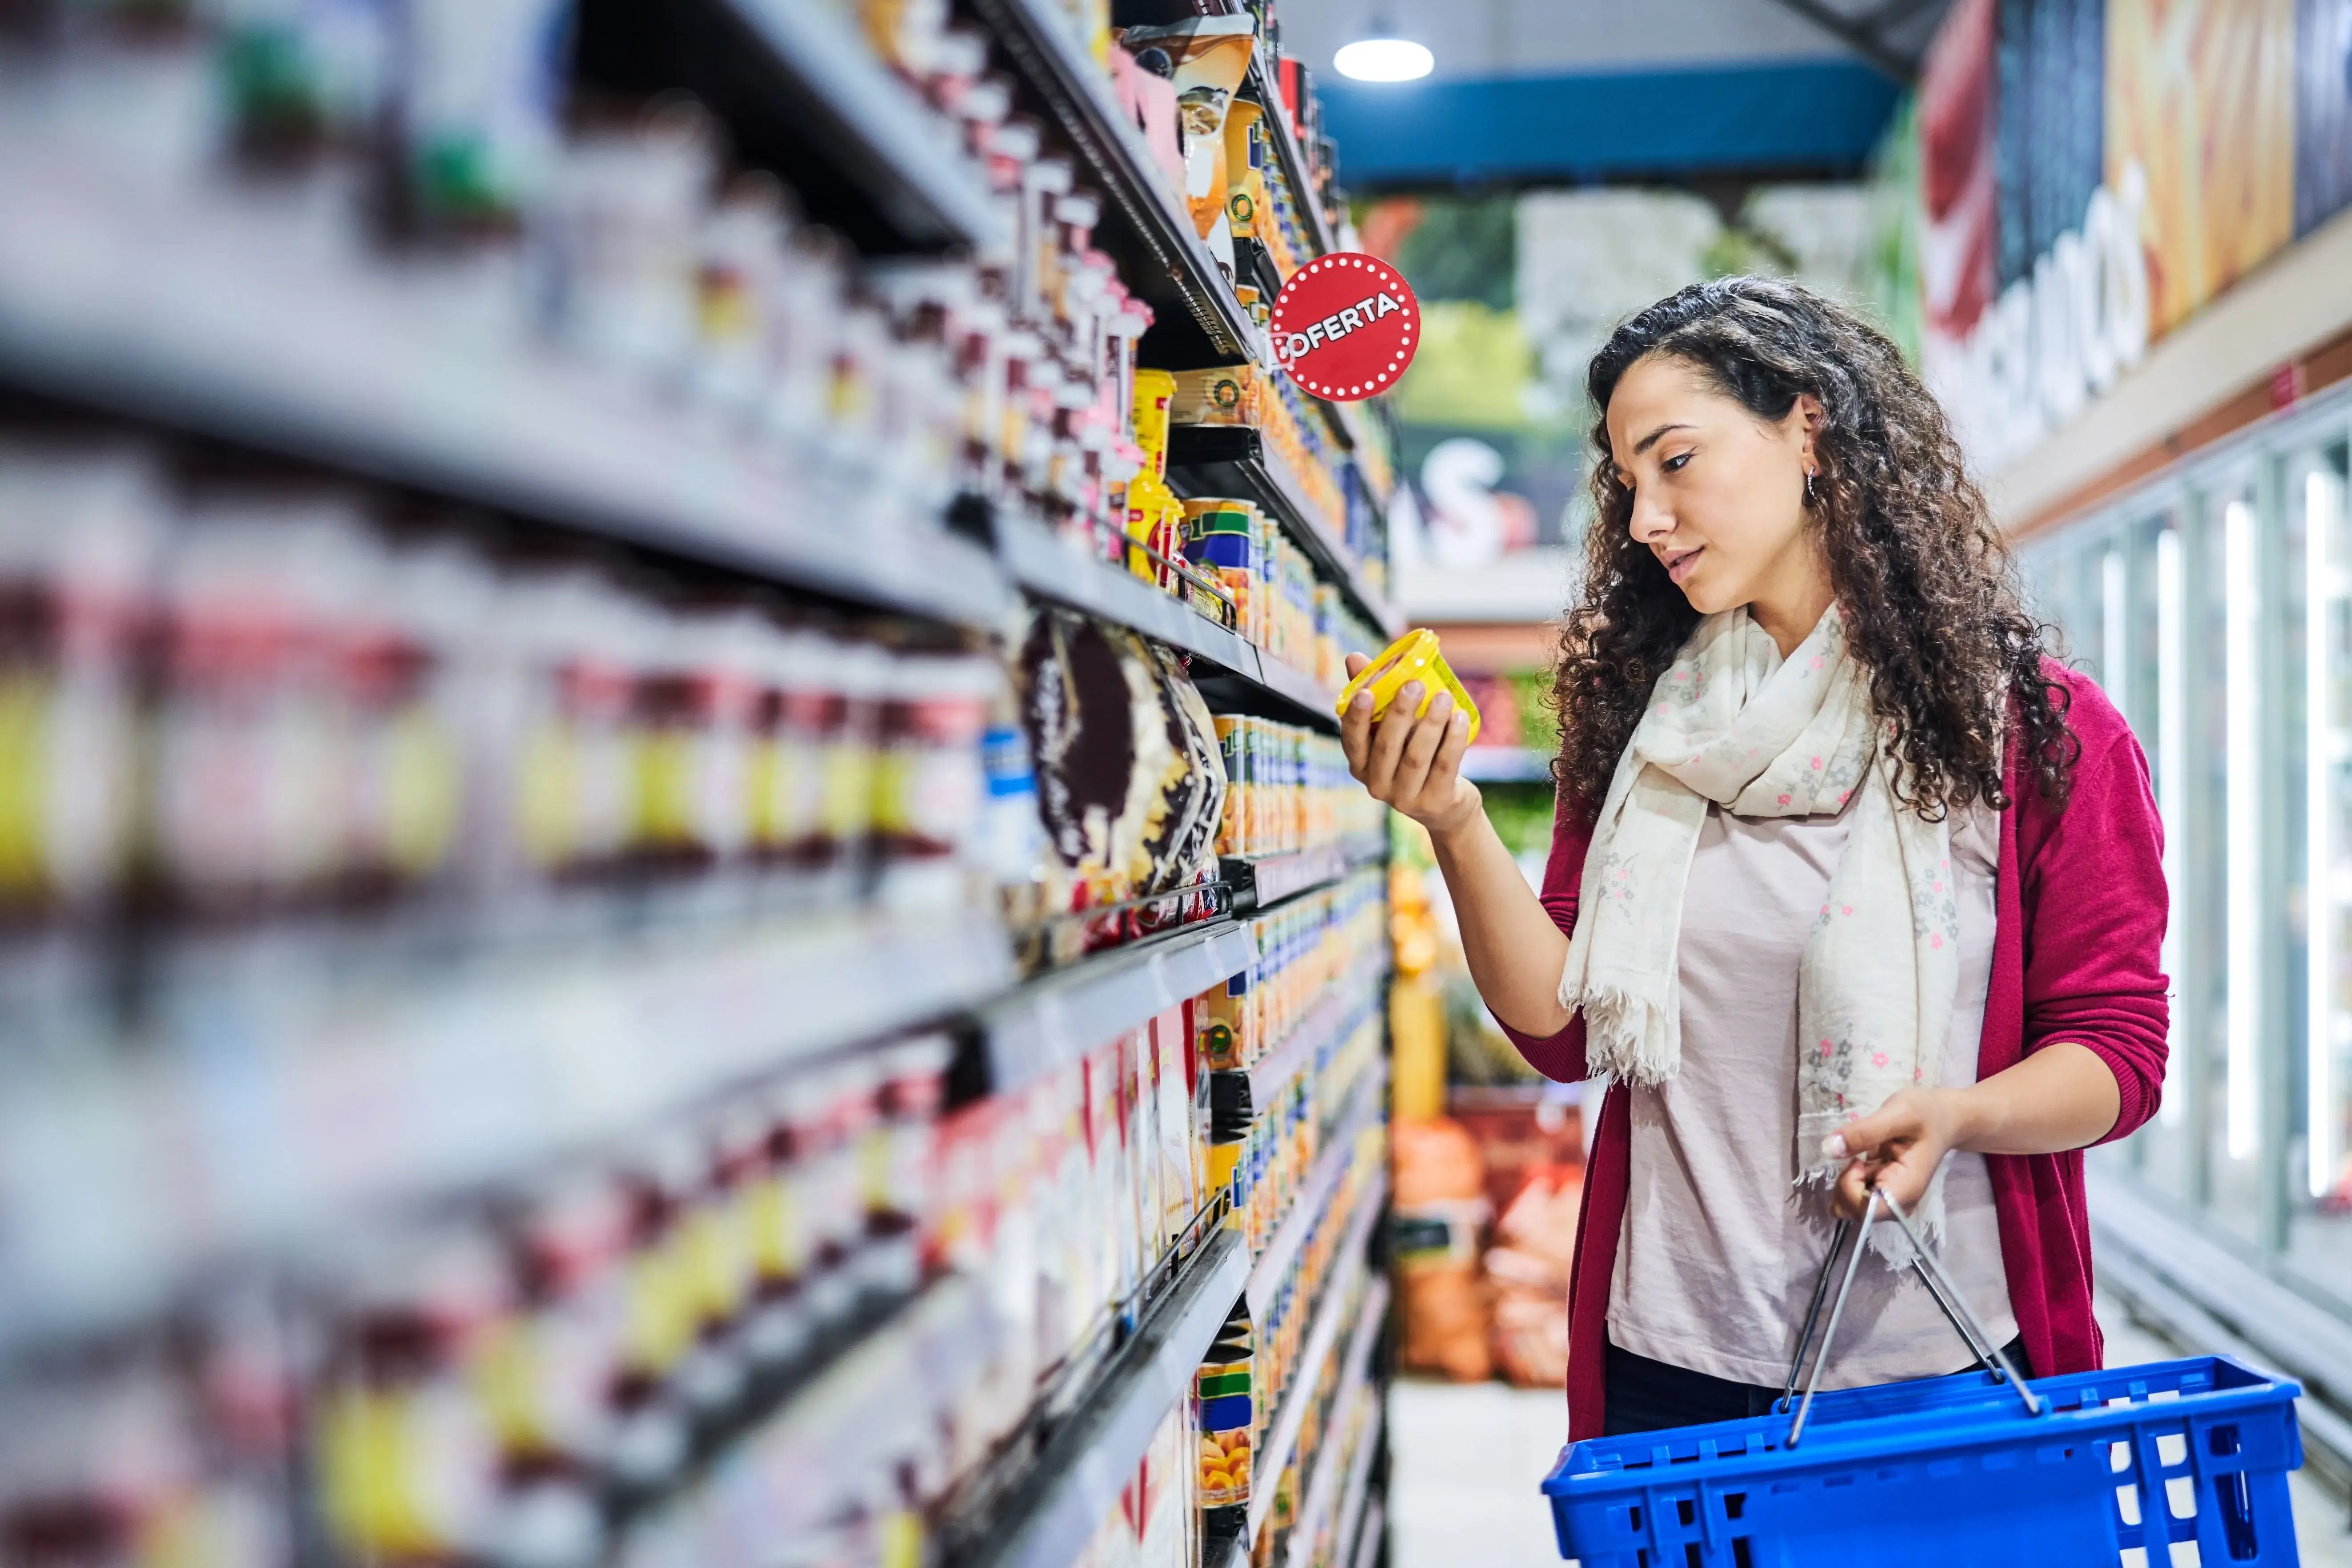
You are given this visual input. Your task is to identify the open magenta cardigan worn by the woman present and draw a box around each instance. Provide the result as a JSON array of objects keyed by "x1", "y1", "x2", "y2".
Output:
[{"x1": 1505, "y1": 663, "x2": 2169, "y2": 1441}]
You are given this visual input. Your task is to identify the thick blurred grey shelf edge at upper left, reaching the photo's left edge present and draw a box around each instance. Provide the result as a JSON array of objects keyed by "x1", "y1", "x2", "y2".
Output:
[{"x1": 0, "y1": 147, "x2": 1011, "y2": 628}]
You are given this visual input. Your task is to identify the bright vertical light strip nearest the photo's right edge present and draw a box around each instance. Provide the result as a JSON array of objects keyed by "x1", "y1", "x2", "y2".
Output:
[{"x1": 2303, "y1": 468, "x2": 2345, "y2": 1197}]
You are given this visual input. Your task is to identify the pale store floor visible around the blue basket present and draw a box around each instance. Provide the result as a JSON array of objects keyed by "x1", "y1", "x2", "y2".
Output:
[{"x1": 1388, "y1": 1300, "x2": 2352, "y2": 1568}]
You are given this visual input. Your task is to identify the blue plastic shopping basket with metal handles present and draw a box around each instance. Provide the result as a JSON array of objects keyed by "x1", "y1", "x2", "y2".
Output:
[{"x1": 1543, "y1": 1197, "x2": 2303, "y2": 1568}]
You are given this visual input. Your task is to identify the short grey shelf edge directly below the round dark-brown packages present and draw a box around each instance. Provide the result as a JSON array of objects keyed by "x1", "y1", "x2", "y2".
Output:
[{"x1": 981, "y1": 919, "x2": 1256, "y2": 1093}]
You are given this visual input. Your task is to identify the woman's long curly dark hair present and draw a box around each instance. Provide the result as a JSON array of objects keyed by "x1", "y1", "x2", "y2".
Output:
[{"x1": 1552, "y1": 278, "x2": 2082, "y2": 818}]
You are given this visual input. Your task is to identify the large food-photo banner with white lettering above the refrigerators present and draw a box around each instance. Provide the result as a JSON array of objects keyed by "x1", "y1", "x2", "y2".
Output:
[{"x1": 1877, "y1": 0, "x2": 2352, "y2": 470}]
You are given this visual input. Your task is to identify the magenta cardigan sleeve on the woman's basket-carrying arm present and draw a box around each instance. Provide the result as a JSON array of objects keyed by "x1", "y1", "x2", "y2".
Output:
[{"x1": 2016, "y1": 679, "x2": 2171, "y2": 1142}]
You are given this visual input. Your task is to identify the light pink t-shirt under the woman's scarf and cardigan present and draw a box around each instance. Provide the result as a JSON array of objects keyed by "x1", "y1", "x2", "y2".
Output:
[{"x1": 1609, "y1": 806, "x2": 2018, "y2": 1387}]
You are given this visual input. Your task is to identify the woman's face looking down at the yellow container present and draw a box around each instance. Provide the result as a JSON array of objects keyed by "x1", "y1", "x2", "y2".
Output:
[{"x1": 1609, "y1": 355, "x2": 1828, "y2": 616}]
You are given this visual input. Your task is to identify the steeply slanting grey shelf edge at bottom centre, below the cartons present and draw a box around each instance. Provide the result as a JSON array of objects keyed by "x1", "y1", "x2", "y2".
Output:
[{"x1": 972, "y1": 1232, "x2": 1249, "y2": 1568}]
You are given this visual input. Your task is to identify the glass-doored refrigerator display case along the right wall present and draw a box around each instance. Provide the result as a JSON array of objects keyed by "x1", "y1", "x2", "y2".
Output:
[{"x1": 2021, "y1": 395, "x2": 2352, "y2": 1321}]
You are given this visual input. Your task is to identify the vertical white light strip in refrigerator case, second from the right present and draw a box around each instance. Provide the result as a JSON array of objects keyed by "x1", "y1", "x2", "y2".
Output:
[{"x1": 2223, "y1": 501, "x2": 2263, "y2": 1159}]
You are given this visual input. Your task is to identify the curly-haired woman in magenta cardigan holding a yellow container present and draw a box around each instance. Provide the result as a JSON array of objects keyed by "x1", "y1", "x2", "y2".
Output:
[{"x1": 1343, "y1": 278, "x2": 2166, "y2": 1439}]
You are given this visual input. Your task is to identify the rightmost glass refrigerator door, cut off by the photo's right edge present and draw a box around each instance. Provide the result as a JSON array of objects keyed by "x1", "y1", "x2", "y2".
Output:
[{"x1": 2279, "y1": 444, "x2": 2352, "y2": 1302}]
